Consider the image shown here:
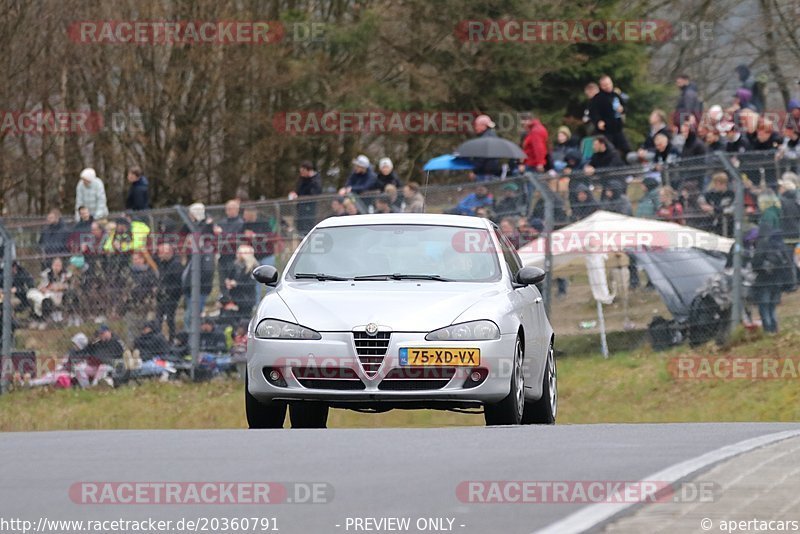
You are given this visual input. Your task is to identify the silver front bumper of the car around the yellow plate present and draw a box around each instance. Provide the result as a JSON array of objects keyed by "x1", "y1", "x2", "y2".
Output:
[{"x1": 247, "y1": 332, "x2": 516, "y2": 407}]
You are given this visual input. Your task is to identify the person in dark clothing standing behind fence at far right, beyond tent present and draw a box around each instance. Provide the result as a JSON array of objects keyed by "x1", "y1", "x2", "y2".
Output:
[{"x1": 752, "y1": 222, "x2": 796, "y2": 333}]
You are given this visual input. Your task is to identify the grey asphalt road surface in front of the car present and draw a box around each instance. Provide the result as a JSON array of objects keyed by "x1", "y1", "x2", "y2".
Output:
[{"x1": 0, "y1": 423, "x2": 800, "y2": 534}]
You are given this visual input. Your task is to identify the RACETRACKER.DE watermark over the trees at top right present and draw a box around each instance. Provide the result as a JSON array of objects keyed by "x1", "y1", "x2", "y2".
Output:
[{"x1": 455, "y1": 19, "x2": 714, "y2": 44}]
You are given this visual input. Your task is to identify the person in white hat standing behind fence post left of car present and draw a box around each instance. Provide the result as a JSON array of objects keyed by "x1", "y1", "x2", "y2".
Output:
[{"x1": 181, "y1": 202, "x2": 216, "y2": 331}]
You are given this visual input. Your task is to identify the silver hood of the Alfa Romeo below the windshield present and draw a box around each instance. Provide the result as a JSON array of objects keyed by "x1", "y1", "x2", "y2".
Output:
[{"x1": 277, "y1": 280, "x2": 501, "y2": 332}]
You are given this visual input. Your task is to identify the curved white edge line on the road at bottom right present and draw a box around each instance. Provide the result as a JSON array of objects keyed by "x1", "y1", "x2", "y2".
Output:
[{"x1": 534, "y1": 430, "x2": 800, "y2": 534}]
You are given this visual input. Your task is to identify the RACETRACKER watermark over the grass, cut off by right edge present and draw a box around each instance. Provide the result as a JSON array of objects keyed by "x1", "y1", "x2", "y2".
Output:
[{"x1": 667, "y1": 356, "x2": 800, "y2": 380}]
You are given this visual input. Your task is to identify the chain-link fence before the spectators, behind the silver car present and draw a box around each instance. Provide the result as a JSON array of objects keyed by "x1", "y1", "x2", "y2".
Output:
[{"x1": 0, "y1": 152, "x2": 800, "y2": 394}]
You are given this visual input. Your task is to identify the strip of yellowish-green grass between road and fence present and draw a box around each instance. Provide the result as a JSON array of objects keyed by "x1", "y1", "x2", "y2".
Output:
[{"x1": 0, "y1": 318, "x2": 800, "y2": 431}]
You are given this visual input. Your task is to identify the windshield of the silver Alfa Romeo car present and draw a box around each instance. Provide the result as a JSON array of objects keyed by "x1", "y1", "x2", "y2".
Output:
[{"x1": 289, "y1": 224, "x2": 501, "y2": 282}]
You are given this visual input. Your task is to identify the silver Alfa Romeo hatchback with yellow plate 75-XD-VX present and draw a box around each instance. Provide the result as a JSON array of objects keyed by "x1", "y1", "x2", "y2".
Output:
[{"x1": 245, "y1": 214, "x2": 558, "y2": 428}]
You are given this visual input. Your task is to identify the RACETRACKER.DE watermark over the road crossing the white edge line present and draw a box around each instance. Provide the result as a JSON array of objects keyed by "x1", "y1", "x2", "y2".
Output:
[{"x1": 456, "y1": 480, "x2": 719, "y2": 504}]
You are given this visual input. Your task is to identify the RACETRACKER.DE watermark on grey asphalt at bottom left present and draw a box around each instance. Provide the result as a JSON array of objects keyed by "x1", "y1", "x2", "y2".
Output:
[{"x1": 68, "y1": 481, "x2": 334, "y2": 505}]
